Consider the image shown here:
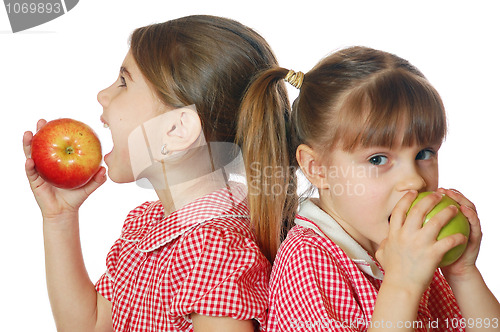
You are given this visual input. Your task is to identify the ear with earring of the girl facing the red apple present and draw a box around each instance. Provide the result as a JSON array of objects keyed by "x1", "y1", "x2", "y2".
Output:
[{"x1": 162, "y1": 107, "x2": 202, "y2": 152}]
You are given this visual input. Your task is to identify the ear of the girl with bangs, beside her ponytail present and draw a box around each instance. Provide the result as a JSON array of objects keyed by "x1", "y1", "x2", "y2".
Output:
[{"x1": 295, "y1": 144, "x2": 328, "y2": 189}]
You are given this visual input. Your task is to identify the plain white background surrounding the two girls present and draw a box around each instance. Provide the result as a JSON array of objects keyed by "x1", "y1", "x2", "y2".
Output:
[{"x1": 0, "y1": 0, "x2": 500, "y2": 331}]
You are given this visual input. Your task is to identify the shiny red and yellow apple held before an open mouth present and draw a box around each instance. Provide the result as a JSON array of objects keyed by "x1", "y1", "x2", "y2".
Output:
[{"x1": 31, "y1": 119, "x2": 102, "y2": 189}]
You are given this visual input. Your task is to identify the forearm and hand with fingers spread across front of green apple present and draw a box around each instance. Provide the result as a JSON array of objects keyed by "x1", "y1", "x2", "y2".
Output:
[{"x1": 369, "y1": 192, "x2": 466, "y2": 331}]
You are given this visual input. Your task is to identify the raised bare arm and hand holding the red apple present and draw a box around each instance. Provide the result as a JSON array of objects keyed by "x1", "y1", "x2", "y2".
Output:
[{"x1": 23, "y1": 120, "x2": 112, "y2": 331}]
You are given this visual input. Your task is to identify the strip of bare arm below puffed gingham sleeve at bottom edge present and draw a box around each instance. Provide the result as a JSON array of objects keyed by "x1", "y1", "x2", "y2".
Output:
[{"x1": 191, "y1": 313, "x2": 254, "y2": 332}]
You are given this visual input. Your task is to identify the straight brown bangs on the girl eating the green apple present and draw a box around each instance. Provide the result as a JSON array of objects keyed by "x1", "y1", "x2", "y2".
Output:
[{"x1": 333, "y1": 70, "x2": 446, "y2": 151}]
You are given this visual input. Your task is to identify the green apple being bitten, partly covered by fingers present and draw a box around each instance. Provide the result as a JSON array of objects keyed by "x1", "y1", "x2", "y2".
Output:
[{"x1": 410, "y1": 191, "x2": 470, "y2": 267}]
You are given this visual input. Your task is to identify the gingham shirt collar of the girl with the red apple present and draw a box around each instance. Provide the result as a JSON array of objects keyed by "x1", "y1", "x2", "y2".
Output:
[{"x1": 121, "y1": 187, "x2": 249, "y2": 252}]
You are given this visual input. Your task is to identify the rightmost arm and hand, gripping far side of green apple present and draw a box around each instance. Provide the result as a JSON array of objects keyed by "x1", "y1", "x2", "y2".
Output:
[{"x1": 440, "y1": 190, "x2": 500, "y2": 331}]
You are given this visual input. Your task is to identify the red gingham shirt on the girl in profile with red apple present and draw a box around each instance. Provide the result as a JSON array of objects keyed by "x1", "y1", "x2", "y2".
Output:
[{"x1": 96, "y1": 189, "x2": 270, "y2": 332}]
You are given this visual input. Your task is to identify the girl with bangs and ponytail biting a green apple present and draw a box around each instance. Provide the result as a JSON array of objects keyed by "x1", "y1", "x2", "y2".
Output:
[{"x1": 240, "y1": 47, "x2": 500, "y2": 332}]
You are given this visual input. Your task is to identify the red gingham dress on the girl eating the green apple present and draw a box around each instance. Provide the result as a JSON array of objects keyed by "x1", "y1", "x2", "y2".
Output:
[{"x1": 266, "y1": 200, "x2": 463, "y2": 332}]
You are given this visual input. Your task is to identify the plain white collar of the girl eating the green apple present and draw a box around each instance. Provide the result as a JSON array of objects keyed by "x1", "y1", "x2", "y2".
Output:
[{"x1": 295, "y1": 199, "x2": 384, "y2": 280}]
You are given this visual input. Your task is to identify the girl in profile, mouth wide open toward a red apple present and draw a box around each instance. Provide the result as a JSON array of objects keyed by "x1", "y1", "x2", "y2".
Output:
[{"x1": 23, "y1": 16, "x2": 287, "y2": 332}]
